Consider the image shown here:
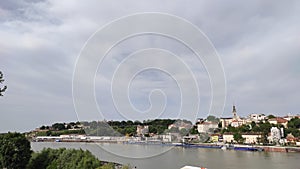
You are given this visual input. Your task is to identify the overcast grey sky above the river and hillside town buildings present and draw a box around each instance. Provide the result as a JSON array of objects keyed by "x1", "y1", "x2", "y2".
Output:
[{"x1": 0, "y1": 0, "x2": 300, "y2": 132}]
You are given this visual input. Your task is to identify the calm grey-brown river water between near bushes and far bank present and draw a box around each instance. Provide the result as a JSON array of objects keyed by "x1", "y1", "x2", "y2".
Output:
[{"x1": 31, "y1": 142, "x2": 300, "y2": 169}]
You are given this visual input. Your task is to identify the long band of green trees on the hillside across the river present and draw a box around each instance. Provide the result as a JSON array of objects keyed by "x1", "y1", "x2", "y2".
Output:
[{"x1": 35, "y1": 119, "x2": 197, "y2": 136}]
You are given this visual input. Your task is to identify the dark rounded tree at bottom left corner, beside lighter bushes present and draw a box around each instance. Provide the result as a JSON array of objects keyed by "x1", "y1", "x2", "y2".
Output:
[{"x1": 0, "y1": 133, "x2": 32, "y2": 169}]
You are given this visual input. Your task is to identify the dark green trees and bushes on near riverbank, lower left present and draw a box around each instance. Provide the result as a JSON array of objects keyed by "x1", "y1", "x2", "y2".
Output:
[{"x1": 0, "y1": 133, "x2": 129, "y2": 169}]
